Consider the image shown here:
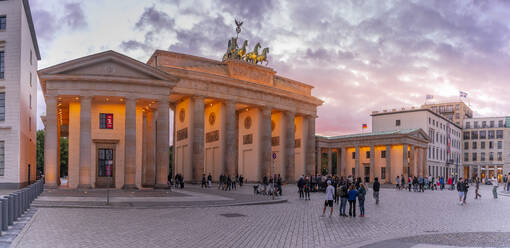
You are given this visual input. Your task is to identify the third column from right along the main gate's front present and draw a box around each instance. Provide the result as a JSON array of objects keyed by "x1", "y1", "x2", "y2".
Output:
[{"x1": 259, "y1": 107, "x2": 272, "y2": 177}]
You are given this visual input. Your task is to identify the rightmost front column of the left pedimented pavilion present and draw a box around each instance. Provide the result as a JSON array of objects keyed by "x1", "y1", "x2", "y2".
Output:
[{"x1": 155, "y1": 98, "x2": 170, "y2": 188}]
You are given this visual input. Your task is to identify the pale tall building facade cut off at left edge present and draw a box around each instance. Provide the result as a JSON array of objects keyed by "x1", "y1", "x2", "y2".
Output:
[{"x1": 0, "y1": 0, "x2": 41, "y2": 188}]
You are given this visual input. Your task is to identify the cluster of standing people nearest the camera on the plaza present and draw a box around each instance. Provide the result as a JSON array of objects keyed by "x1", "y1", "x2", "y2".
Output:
[{"x1": 318, "y1": 177, "x2": 381, "y2": 218}]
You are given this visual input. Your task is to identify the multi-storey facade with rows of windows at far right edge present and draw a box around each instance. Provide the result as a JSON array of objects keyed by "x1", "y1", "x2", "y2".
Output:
[{"x1": 462, "y1": 117, "x2": 510, "y2": 181}]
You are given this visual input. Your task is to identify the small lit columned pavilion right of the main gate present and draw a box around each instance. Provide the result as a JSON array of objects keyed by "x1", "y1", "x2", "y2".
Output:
[{"x1": 316, "y1": 128, "x2": 430, "y2": 183}]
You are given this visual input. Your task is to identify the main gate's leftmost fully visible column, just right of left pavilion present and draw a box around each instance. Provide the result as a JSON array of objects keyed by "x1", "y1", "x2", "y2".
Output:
[{"x1": 191, "y1": 96, "x2": 205, "y2": 182}]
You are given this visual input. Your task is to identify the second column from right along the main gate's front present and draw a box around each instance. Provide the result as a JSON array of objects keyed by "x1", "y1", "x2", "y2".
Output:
[{"x1": 284, "y1": 112, "x2": 296, "y2": 183}]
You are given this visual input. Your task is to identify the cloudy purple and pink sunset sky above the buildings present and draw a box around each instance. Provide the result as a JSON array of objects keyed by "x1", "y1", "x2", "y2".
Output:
[{"x1": 30, "y1": 0, "x2": 510, "y2": 135}]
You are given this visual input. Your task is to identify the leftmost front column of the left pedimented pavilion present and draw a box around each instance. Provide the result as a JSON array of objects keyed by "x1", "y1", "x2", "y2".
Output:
[{"x1": 44, "y1": 95, "x2": 58, "y2": 188}]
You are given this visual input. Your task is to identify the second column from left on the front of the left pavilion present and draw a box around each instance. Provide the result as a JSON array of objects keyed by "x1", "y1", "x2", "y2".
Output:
[{"x1": 78, "y1": 96, "x2": 92, "y2": 188}]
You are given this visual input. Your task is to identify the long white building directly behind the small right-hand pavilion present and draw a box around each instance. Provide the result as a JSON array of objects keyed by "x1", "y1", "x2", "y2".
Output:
[{"x1": 371, "y1": 108, "x2": 462, "y2": 177}]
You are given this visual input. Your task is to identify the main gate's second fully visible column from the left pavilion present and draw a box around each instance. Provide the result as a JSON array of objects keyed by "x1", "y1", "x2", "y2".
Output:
[{"x1": 223, "y1": 101, "x2": 238, "y2": 176}]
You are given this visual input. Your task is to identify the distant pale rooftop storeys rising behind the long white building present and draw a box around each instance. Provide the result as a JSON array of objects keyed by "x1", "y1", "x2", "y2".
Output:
[{"x1": 421, "y1": 101, "x2": 473, "y2": 126}]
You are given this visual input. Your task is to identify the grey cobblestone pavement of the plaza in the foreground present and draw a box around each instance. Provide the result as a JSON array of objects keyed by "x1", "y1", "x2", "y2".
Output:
[{"x1": 9, "y1": 185, "x2": 510, "y2": 248}]
